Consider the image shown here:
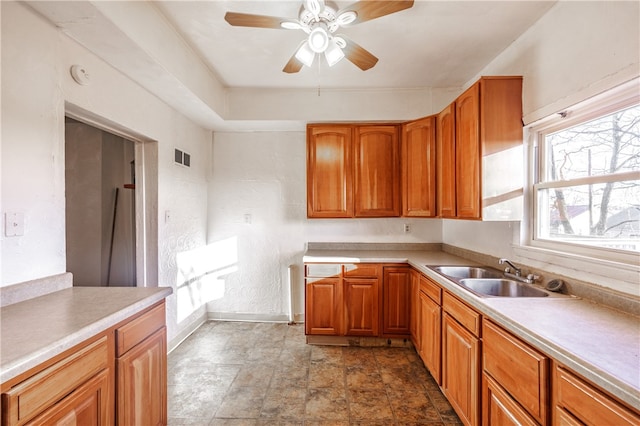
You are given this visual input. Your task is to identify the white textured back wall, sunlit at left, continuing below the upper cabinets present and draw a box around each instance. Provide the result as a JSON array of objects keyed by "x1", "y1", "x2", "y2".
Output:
[{"x1": 207, "y1": 132, "x2": 442, "y2": 319}]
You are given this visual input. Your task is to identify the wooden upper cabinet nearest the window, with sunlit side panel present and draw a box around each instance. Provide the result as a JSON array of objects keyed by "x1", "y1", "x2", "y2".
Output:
[{"x1": 455, "y1": 77, "x2": 523, "y2": 220}]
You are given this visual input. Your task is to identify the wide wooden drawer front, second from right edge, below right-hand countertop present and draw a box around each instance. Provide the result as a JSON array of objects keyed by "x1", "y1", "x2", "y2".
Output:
[{"x1": 482, "y1": 321, "x2": 549, "y2": 424}]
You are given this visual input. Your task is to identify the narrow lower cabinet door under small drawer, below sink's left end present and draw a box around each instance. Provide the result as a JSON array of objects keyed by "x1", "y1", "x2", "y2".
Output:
[{"x1": 420, "y1": 291, "x2": 442, "y2": 385}]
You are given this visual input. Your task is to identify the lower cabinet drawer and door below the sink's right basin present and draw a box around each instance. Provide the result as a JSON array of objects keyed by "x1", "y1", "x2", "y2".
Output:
[{"x1": 442, "y1": 292, "x2": 481, "y2": 426}]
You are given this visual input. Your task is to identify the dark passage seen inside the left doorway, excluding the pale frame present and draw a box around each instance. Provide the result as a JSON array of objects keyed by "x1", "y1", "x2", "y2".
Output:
[{"x1": 65, "y1": 117, "x2": 137, "y2": 287}]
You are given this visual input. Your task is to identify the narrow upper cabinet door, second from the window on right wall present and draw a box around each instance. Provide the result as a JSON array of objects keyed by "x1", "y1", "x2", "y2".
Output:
[{"x1": 436, "y1": 102, "x2": 456, "y2": 217}]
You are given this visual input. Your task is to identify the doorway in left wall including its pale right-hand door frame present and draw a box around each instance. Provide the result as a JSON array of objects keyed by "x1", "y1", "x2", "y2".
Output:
[{"x1": 65, "y1": 103, "x2": 158, "y2": 287}]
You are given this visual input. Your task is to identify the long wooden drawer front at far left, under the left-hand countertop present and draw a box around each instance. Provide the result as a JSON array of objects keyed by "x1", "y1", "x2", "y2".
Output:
[{"x1": 2, "y1": 336, "x2": 113, "y2": 425}]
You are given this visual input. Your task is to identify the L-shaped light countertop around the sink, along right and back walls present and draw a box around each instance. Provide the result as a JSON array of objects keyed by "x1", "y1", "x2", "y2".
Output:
[{"x1": 303, "y1": 249, "x2": 640, "y2": 410}]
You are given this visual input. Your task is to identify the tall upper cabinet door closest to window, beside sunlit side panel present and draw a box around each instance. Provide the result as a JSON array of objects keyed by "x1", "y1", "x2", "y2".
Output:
[{"x1": 456, "y1": 83, "x2": 481, "y2": 219}]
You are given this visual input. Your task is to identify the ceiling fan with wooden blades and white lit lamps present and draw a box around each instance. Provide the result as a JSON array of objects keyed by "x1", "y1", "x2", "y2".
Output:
[{"x1": 224, "y1": 0, "x2": 413, "y2": 73}]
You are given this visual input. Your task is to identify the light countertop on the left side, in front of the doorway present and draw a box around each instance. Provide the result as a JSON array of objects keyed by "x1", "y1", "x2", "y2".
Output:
[{"x1": 0, "y1": 287, "x2": 172, "y2": 383}]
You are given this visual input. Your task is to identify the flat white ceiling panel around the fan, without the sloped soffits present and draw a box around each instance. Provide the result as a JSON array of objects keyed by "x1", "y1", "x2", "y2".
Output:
[{"x1": 156, "y1": 0, "x2": 553, "y2": 88}]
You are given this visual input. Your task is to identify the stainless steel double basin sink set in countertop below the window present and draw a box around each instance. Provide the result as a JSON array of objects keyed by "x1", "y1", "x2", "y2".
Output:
[{"x1": 430, "y1": 266, "x2": 549, "y2": 297}]
